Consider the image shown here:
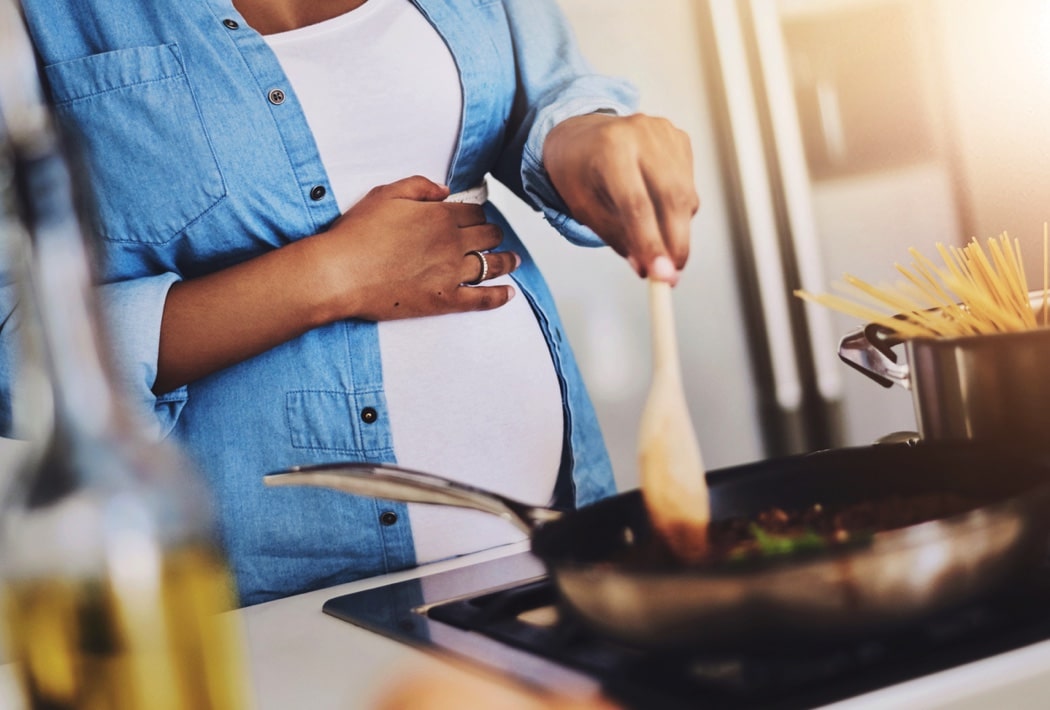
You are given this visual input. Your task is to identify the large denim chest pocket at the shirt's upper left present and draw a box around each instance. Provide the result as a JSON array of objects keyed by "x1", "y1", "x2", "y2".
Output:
[{"x1": 44, "y1": 44, "x2": 226, "y2": 245}]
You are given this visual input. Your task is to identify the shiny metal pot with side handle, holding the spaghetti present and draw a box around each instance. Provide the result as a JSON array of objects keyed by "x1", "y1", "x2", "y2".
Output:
[{"x1": 839, "y1": 291, "x2": 1050, "y2": 454}]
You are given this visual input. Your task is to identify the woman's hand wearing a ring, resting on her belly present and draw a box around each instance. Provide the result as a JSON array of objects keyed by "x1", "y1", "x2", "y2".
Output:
[{"x1": 314, "y1": 175, "x2": 521, "y2": 320}]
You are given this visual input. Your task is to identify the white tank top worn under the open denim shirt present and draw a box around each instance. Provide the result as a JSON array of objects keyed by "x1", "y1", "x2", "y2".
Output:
[{"x1": 266, "y1": 0, "x2": 563, "y2": 563}]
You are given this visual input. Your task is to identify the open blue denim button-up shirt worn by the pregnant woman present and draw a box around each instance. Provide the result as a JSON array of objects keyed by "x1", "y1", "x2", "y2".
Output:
[{"x1": 23, "y1": 0, "x2": 634, "y2": 603}]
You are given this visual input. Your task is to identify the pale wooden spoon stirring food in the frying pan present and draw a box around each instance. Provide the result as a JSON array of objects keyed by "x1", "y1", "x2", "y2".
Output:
[{"x1": 638, "y1": 279, "x2": 711, "y2": 562}]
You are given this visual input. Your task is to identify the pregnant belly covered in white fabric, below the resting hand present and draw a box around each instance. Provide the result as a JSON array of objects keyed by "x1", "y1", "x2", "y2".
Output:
[{"x1": 379, "y1": 276, "x2": 563, "y2": 563}]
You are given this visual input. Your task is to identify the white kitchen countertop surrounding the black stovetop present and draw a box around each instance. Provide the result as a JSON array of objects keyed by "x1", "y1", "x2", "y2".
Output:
[{"x1": 6, "y1": 543, "x2": 1050, "y2": 710}]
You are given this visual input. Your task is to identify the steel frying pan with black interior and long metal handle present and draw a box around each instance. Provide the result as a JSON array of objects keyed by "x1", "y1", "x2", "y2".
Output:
[{"x1": 265, "y1": 442, "x2": 1050, "y2": 648}]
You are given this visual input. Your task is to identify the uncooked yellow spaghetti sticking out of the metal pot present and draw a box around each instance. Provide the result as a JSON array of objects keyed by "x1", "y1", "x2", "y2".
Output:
[{"x1": 795, "y1": 225, "x2": 1050, "y2": 338}]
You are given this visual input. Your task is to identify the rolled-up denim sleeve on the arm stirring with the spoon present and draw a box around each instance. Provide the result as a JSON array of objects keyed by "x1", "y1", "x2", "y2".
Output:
[{"x1": 497, "y1": 0, "x2": 637, "y2": 246}]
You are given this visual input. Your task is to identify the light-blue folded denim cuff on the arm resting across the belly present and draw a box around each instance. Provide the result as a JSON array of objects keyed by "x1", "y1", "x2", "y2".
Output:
[{"x1": 100, "y1": 273, "x2": 187, "y2": 436}]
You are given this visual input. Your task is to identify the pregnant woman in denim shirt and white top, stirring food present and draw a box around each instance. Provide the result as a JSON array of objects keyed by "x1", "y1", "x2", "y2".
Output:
[{"x1": 12, "y1": 0, "x2": 699, "y2": 604}]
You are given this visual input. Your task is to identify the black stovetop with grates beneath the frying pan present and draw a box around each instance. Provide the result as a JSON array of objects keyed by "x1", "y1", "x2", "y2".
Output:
[{"x1": 323, "y1": 552, "x2": 1050, "y2": 710}]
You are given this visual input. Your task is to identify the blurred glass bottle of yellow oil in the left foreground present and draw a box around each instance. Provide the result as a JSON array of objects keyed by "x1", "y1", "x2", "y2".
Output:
[{"x1": 0, "y1": 0, "x2": 248, "y2": 710}]
